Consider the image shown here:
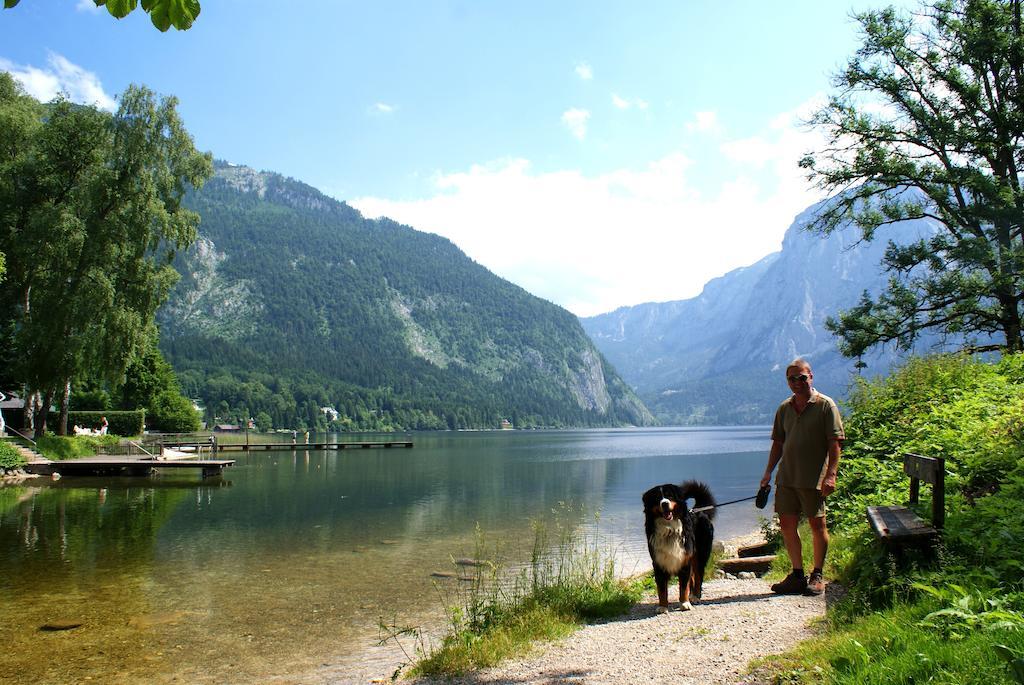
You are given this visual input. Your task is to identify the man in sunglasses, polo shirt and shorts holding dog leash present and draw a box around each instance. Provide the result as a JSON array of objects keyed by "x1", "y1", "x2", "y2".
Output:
[{"x1": 761, "y1": 359, "x2": 845, "y2": 595}]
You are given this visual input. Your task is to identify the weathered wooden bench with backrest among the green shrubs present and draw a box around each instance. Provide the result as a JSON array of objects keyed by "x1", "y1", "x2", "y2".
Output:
[{"x1": 867, "y1": 454, "x2": 946, "y2": 547}]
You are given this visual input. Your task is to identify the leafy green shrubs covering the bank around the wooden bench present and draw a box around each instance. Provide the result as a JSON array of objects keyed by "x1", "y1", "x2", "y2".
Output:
[{"x1": 828, "y1": 354, "x2": 1024, "y2": 616}]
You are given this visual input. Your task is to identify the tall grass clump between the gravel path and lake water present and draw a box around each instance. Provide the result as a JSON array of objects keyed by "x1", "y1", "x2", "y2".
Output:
[{"x1": 411, "y1": 505, "x2": 643, "y2": 676}]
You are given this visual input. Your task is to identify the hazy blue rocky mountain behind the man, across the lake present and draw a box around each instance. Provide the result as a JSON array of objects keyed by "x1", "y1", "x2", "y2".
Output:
[{"x1": 583, "y1": 194, "x2": 950, "y2": 424}]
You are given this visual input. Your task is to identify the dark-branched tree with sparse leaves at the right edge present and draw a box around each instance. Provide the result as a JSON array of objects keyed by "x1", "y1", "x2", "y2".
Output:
[{"x1": 801, "y1": 0, "x2": 1024, "y2": 356}]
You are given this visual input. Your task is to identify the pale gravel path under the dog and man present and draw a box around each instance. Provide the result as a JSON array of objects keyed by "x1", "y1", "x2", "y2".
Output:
[{"x1": 416, "y1": 579, "x2": 825, "y2": 685}]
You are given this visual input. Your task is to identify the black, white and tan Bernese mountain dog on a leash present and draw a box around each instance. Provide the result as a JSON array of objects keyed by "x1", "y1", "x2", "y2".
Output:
[{"x1": 643, "y1": 480, "x2": 715, "y2": 613}]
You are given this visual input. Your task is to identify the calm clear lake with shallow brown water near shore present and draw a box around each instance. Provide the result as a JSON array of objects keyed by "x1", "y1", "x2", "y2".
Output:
[{"x1": 0, "y1": 426, "x2": 769, "y2": 683}]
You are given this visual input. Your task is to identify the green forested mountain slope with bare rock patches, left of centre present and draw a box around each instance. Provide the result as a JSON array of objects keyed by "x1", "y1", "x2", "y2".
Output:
[{"x1": 159, "y1": 163, "x2": 651, "y2": 429}]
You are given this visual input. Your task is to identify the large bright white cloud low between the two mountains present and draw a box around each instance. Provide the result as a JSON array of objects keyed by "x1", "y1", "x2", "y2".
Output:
[{"x1": 350, "y1": 96, "x2": 820, "y2": 316}]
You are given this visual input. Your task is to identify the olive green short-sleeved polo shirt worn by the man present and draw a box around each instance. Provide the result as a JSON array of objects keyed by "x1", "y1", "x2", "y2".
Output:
[{"x1": 771, "y1": 390, "x2": 846, "y2": 488}]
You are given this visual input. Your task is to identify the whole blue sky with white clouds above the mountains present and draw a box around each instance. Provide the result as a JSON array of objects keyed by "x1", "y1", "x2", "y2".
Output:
[{"x1": 0, "y1": 0, "x2": 912, "y2": 315}]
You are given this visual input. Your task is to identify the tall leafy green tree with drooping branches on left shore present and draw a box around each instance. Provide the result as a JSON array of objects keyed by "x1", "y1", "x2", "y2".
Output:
[{"x1": 0, "y1": 74, "x2": 212, "y2": 433}]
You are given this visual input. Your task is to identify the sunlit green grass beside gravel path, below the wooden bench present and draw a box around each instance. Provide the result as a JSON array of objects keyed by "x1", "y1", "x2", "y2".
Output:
[{"x1": 754, "y1": 523, "x2": 1024, "y2": 685}]
